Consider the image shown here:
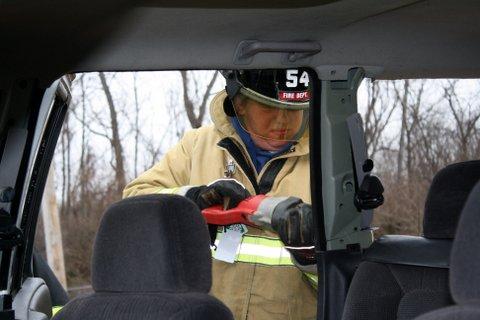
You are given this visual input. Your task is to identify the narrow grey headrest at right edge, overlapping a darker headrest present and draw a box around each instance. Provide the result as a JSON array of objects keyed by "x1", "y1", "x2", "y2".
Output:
[{"x1": 450, "y1": 183, "x2": 480, "y2": 303}]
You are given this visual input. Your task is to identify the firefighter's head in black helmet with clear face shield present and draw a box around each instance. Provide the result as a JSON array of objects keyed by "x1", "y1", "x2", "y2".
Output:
[{"x1": 226, "y1": 68, "x2": 310, "y2": 146}]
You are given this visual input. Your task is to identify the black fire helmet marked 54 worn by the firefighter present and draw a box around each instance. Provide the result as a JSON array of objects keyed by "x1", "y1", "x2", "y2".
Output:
[{"x1": 222, "y1": 68, "x2": 310, "y2": 117}]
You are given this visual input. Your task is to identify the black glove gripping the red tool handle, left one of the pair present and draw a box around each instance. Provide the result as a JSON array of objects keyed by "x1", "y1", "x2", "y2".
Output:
[{"x1": 185, "y1": 179, "x2": 250, "y2": 210}]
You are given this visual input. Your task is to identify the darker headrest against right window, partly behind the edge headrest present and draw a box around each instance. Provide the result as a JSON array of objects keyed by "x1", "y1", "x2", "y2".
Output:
[{"x1": 423, "y1": 161, "x2": 480, "y2": 239}]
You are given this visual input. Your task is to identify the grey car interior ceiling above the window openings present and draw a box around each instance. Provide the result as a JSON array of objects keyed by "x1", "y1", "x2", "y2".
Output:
[{"x1": 0, "y1": 0, "x2": 480, "y2": 83}]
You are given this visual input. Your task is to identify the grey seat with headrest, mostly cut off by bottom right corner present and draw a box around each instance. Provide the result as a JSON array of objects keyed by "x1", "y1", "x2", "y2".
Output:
[{"x1": 416, "y1": 183, "x2": 480, "y2": 320}]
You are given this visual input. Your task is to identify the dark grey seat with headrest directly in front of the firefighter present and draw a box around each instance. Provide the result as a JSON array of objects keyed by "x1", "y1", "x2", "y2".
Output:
[{"x1": 53, "y1": 195, "x2": 233, "y2": 320}]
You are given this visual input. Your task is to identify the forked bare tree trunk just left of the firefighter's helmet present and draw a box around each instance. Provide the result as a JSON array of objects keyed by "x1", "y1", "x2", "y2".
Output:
[{"x1": 180, "y1": 70, "x2": 218, "y2": 128}]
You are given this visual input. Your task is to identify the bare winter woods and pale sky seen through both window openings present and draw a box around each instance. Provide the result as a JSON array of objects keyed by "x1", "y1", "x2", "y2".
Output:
[{"x1": 36, "y1": 71, "x2": 480, "y2": 295}]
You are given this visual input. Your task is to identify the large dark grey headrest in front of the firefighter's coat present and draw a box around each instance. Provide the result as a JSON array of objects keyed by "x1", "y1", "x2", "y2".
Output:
[{"x1": 92, "y1": 195, "x2": 212, "y2": 293}]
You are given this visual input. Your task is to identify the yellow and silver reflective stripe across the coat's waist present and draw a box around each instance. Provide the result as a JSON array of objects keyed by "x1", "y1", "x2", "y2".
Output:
[{"x1": 212, "y1": 233, "x2": 294, "y2": 266}]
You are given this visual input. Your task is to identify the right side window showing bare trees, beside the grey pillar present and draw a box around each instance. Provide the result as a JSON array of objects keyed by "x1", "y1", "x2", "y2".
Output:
[{"x1": 358, "y1": 79, "x2": 480, "y2": 235}]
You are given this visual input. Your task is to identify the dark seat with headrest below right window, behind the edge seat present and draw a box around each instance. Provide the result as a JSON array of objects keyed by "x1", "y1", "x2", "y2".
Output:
[{"x1": 342, "y1": 161, "x2": 480, "y2": 320}]
